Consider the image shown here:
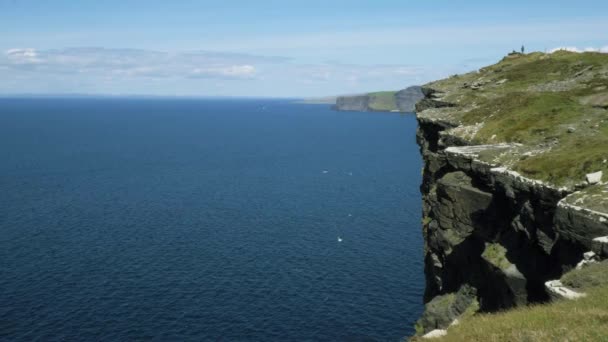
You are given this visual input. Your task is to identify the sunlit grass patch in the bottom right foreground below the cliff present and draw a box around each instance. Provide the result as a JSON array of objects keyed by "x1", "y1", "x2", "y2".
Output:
[{"x1": 413, "y1": 261, "x2": 608, "y2": 342}]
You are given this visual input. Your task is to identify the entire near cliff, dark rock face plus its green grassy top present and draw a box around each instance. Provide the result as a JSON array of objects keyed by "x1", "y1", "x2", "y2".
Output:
[{"x1": 416, "y1": 52, "x2": 608, "y2": 335}]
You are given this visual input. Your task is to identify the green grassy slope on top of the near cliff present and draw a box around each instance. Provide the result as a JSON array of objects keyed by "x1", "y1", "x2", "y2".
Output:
[{"x1": 422, "y1": 51, "x2": 608, "y2": 185}]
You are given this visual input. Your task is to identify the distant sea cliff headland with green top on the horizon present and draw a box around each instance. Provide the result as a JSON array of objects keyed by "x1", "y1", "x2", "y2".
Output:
[{"x1": 333, "y1": 86, "x2": 424, "y2": 112}]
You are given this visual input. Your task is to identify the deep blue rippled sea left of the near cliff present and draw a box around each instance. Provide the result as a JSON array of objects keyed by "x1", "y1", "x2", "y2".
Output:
[{"x1": 0, "y1": 98, "x2": 424, "y2": 341}]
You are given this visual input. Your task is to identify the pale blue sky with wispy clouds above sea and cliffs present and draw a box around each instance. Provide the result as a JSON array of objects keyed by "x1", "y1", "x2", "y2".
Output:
[{"x1": 0, "y1": 0, "x2": 608, "y2": 97}]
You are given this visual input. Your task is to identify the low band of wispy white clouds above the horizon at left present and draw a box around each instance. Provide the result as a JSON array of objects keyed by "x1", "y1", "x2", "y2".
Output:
[{"x1": 0, "y1": 48, "x2": 288, "y2": 79}]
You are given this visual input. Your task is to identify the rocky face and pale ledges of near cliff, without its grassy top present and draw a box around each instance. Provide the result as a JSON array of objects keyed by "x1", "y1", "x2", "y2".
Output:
[{"x1": 417, "y1": 52, "x2": 608, "y2": 334}]
